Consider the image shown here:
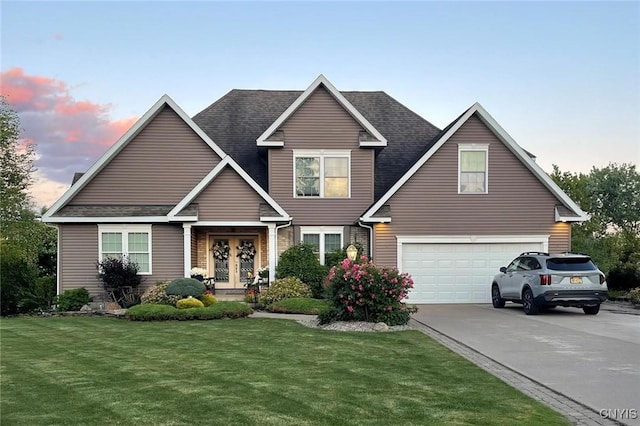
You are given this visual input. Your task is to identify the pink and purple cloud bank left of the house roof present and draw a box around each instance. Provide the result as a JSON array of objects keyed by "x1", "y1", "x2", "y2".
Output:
[{"x1": 0, "y1": 68, "x2": 137, "y2": 209}]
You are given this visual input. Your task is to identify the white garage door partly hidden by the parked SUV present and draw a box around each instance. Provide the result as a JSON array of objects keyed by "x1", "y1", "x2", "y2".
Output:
[{"x1": 399, "y1": 242, "x2": 547, "y2": 303}]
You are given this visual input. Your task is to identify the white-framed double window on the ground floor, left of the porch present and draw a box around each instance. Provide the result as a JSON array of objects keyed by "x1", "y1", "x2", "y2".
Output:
[{"x1": 98, "y1": 225, "x2": 151, "y2": 275}]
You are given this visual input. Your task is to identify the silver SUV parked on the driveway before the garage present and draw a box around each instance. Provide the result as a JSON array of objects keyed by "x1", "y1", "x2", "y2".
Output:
[{"x1": 491, "y1": 252, "x2": 607, "y2": 315}]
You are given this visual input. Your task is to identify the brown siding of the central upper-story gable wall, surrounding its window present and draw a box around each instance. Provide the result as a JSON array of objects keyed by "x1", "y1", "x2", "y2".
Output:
[{"x1": 269, "y1": 88, "x2": 374, "y2": 225}]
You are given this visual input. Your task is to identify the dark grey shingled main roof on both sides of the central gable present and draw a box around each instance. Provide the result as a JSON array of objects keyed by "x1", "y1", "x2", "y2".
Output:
[{"x1": 193, "y1": 89, "x2": 440, "y2": 198}]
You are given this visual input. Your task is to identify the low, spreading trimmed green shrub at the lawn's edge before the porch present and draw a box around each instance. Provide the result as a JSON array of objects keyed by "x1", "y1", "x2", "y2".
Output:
[{"x1": 125, "y1": 302, "x2": 253, "y2": 321}]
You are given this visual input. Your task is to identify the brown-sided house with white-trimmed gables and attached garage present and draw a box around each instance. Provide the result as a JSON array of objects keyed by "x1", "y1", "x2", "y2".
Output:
[{"x1": 43, "y1": 75, "x2": 586, "y2": 303}]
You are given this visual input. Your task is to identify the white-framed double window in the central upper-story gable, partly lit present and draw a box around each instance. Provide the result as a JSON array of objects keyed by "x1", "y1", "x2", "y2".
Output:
[{"x1": 293, "y1": 150, "x2": 351, "y2": 198}]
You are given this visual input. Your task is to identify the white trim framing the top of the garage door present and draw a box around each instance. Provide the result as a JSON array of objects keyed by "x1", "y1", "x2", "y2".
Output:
[{"x1": 396, "y1": 235, "x2": 550, "y2": 266}]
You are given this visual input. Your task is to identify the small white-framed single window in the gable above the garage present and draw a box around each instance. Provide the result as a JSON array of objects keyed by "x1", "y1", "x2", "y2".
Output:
[{"x1": 458, "y1": 144, "x2": 489, "y2": 194}]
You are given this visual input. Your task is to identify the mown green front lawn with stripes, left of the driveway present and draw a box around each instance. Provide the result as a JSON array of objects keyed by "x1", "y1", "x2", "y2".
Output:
[{"x1": 0, "y1": 317, "x2": 569, "y2": 426}]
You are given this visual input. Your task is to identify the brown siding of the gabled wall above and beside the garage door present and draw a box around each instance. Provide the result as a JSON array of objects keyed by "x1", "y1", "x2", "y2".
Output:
[{"x1": 374, "y1": 116, "x2": 569, "y2": 266}]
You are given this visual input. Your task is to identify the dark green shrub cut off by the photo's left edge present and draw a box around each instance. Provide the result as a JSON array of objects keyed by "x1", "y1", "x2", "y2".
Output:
[{"x1": 0, "y1": 242, "x2": 38, "y2": 316}]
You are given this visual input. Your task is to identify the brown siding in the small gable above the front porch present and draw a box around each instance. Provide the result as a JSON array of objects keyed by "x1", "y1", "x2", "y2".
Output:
[{"x1": 195, "y1": 167, "x2": 263, "y2": 221}]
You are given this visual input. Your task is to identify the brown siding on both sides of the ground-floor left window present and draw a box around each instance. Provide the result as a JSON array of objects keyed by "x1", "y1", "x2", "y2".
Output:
[{"x1": 58, "y1": 224, "x2": 183, "y2": 299}]
